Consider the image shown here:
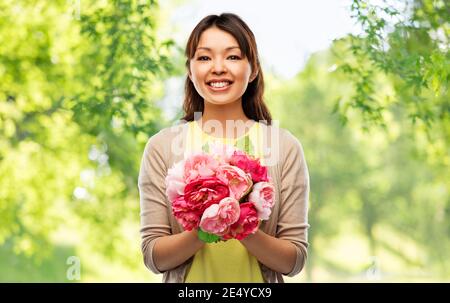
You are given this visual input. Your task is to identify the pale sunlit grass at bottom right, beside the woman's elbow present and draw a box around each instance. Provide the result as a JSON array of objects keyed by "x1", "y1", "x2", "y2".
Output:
[{"x1": 285, "y1": 224, "x2": 450, "y2": 283}]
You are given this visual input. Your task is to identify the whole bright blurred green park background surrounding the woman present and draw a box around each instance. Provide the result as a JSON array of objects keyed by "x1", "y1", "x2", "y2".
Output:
[{"x1": 0, "y1": 0, "x2": 450, "y2": 282}]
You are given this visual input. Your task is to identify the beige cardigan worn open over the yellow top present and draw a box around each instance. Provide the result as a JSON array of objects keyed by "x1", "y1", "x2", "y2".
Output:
[{"x1": 138, "y1": 123, "x2": 310, "y2": 283}]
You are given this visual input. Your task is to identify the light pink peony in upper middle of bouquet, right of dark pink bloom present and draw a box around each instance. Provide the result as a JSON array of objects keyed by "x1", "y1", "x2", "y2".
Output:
[{"x1": 216, "y1": 164, "x2": 253, "y2": 201}]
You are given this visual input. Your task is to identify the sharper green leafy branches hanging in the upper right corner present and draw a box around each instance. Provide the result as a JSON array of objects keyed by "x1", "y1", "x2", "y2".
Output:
[{"x1": 331, "y1": 0, "x2": 450, "y2": 192}]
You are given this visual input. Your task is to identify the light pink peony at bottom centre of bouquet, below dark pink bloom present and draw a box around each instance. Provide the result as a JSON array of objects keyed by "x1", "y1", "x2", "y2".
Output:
[{"x1": 200, "y1": 197, "x2": 240, "y2": 236}]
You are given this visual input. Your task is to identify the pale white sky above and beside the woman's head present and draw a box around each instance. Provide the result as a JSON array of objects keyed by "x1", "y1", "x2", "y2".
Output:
[{"x1": 156, "y1": 0, "x2": 359, "y2": 120}]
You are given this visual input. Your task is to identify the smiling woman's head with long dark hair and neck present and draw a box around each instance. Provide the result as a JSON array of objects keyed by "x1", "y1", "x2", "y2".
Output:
[{"x1": 179, "y1": 14, "x2": 272, "y2": 129}]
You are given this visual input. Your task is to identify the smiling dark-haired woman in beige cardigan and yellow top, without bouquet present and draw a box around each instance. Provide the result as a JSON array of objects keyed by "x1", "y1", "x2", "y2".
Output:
[{"x1": 139, "y1": 13, "x2": 309, "y2": 282}]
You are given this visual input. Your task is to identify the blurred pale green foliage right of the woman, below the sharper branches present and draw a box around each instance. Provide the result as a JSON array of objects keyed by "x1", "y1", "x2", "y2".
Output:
[{"x1": 267, "y1": 41, "x2": 450, "y2": 280}]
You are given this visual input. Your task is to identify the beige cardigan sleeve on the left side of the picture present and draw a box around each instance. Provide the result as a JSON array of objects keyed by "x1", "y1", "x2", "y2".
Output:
[{"x1": 138, "y1": 134, "x2": 171, "y2": 274}]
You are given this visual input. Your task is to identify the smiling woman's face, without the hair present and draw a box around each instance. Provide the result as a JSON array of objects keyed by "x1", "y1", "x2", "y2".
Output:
[{"x1": 189, "y1": 27, "x2": 254, "y2": 105}]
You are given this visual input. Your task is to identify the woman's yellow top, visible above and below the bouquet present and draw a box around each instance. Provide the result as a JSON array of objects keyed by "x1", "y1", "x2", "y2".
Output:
[{"x1": 185, "y1": 121, "x2": 264, "y2": 283}]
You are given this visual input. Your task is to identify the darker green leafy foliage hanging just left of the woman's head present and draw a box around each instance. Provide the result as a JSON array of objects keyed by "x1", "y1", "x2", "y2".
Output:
[{"x1": 71, "y1": 0, "x2": 173, "y2": 134}]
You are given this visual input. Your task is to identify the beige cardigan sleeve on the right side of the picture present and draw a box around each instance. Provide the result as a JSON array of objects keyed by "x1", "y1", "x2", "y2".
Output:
[{"x1": 277, "y1": 130, "x2": 309, "y2": 277}]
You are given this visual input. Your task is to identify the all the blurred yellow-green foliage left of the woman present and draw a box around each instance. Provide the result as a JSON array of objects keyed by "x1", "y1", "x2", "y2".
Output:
[{"x1": 0, "y1": 0, "x2": 173, "y2": 279}]
